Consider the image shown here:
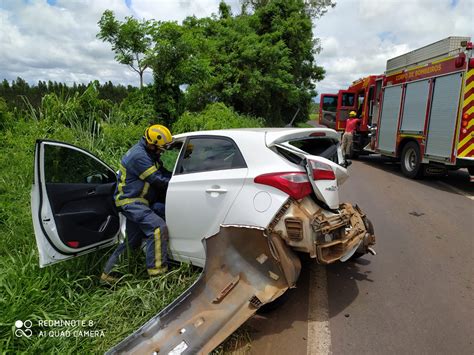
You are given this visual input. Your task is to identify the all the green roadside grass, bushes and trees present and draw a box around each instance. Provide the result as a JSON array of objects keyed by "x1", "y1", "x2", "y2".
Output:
[{"x1": 0, "y1": 0, "x2": 333, "y2": 353}]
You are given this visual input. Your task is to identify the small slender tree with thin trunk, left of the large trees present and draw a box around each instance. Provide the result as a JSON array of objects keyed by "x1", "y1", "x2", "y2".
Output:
[{"x1": 97, "y1": 10, "x2": 151, "y2": 88}]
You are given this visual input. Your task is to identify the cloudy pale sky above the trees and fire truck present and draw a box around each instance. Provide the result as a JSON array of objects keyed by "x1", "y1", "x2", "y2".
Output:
[{"x1": 0, "y1": 0, "x2": 474, "y2": 98}]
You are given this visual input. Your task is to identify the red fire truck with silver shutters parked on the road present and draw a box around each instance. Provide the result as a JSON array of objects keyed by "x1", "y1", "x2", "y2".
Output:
[{"x1": 319, "y1": 37, "x2": 474, "y2": 178}]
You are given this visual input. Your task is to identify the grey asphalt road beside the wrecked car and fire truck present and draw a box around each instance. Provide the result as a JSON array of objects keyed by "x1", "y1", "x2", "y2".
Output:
[{"x1": 246, "y1": 156, "x2": 474, "y2": 355}]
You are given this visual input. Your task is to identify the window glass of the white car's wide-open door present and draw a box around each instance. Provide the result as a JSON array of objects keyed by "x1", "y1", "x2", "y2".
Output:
[{"x1": 44, "y1": 144, "x2": 116, "y2": 184}]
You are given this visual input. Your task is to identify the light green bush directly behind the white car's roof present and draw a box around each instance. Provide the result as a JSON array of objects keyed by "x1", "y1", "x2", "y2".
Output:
[{"x1": 172, "y1": 102, "x2": 264, "y2": 134}]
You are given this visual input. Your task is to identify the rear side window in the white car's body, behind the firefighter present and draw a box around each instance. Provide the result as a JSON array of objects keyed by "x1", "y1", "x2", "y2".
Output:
[{"x1": 176, "y1": 137, "x2": 247, "y2": 174}]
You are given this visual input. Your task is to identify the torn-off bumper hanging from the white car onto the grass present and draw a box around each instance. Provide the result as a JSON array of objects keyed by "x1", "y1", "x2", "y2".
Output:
[{"x1": 107, "y1": 226, "x2": 301, "y2": 354}]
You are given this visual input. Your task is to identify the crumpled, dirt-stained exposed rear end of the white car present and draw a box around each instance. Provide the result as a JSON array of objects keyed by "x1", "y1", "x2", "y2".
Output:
[{"x1": 269, "y1": 198, "x2": 375, "y2": 264}]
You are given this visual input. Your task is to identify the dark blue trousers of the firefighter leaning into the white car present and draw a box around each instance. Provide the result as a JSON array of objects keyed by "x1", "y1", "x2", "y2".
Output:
[{"x1": 104, "y1": 202, "x2": 168, "y2": 275}]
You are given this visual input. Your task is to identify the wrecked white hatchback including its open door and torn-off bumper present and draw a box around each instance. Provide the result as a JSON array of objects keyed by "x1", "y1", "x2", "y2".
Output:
[{"x1": 32, "y1": 128, "x2": 375, "y2": 354}]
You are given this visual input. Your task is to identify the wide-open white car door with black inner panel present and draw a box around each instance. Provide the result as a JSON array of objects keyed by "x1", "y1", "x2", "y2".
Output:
[{"x1": 31, "y1": 140, "x2": 120, "y2": 267}]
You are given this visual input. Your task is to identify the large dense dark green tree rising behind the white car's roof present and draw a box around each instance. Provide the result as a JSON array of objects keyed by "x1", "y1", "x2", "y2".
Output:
[{"x1": 179, "y1": 0, "x2": 332, "y2": 125}]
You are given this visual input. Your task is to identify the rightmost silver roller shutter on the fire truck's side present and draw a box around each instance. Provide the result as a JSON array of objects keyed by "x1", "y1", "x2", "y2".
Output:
[{"x1": 425, "y1": 73, "x2": 462, "y2": 159}]
